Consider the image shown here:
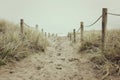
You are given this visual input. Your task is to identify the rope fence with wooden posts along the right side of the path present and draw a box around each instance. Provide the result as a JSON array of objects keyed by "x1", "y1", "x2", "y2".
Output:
[{"x1": 68, "y1": 8, "x2": 120, "y2": 53}]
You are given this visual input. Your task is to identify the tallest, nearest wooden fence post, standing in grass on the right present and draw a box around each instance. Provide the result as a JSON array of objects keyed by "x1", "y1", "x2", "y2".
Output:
[{"x1": 102, "y1": 8, "x2": 107, "y2": 53}]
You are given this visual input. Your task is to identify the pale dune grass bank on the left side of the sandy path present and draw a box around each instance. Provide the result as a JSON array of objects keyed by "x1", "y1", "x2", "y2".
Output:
[{"x1": 0, "y1": 20, "x2": 48, "y2": 65}]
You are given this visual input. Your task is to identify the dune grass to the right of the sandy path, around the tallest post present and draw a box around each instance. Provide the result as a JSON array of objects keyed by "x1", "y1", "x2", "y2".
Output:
[{"x1": 80, "y1": 30, "x2": 120, "y2": 80}]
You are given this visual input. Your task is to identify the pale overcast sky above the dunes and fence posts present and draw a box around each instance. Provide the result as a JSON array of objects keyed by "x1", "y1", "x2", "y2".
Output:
[{"x1": 0, "y1": 0, "x2": 120, "y2": 34}]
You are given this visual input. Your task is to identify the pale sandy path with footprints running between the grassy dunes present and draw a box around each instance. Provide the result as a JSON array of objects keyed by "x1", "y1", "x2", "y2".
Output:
[{"x1": 0, "y1": 37, "x2": 97, "y2": 80}]
